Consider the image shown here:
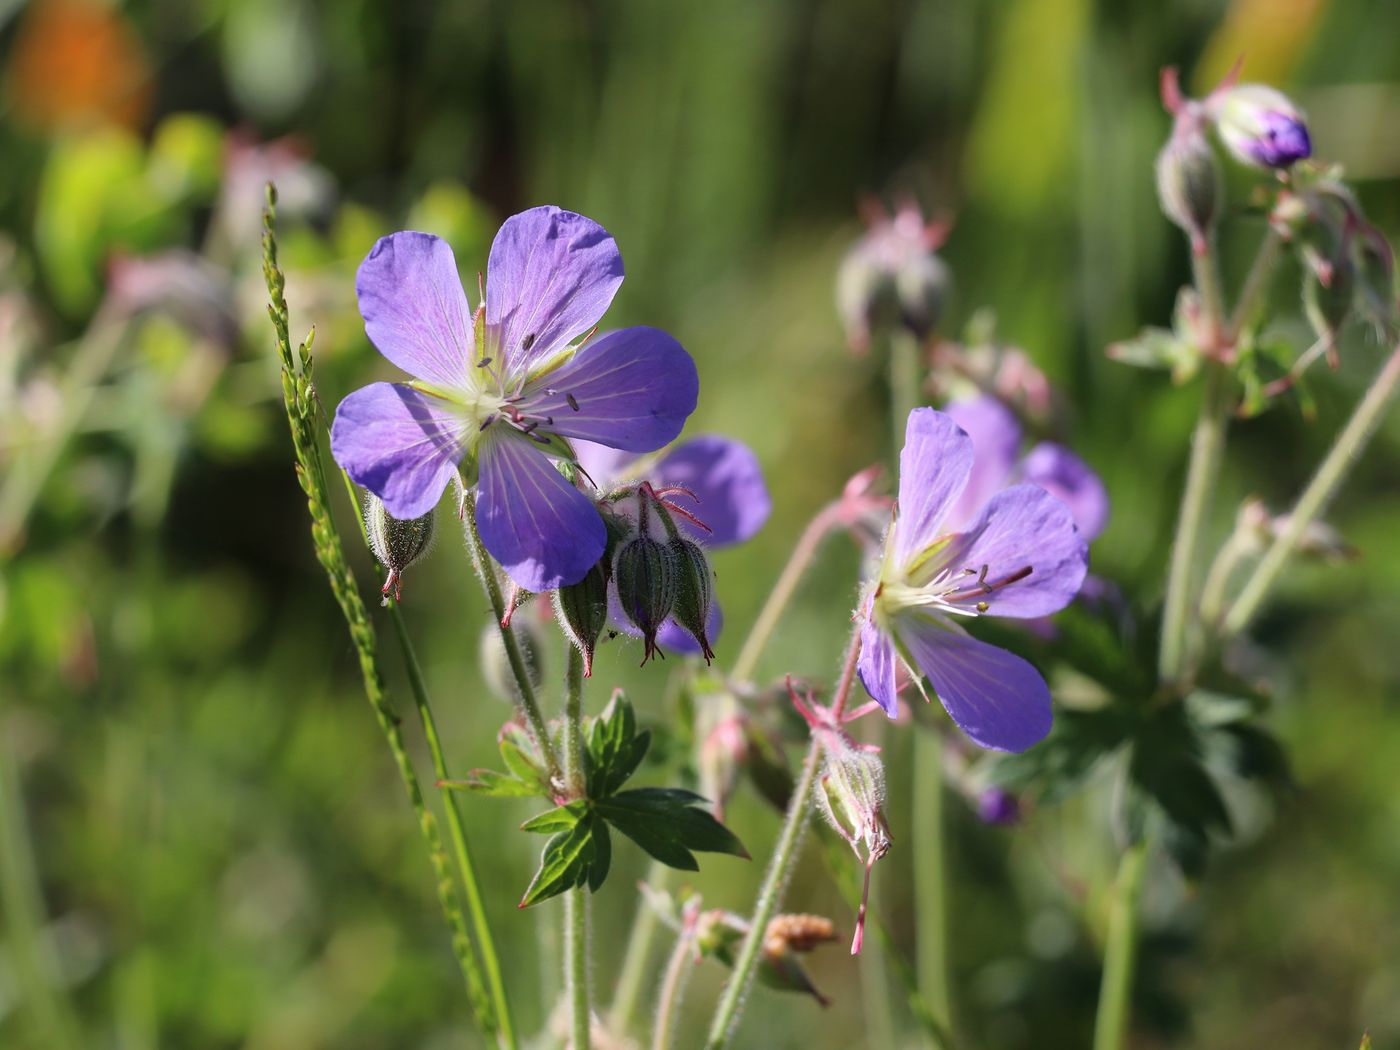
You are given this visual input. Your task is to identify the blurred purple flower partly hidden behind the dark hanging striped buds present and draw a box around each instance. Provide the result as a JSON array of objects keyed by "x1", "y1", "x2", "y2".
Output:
[{"x1": 574, "y1": 434, "x2": 773, "y2": 654}]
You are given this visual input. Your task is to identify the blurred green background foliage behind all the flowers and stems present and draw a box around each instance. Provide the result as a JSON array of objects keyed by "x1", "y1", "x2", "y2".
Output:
[{"x1": 0, "y1": 0, "x2": 1400, "y2": 1050}]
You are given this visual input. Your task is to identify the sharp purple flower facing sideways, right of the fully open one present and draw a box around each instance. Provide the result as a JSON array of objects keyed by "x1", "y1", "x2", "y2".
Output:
[{"x1": 858, "y1": 409, "x2": 1088, "y2": 750}]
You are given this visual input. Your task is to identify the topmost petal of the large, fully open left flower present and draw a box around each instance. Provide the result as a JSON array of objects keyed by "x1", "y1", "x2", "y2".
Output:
[{"x1": 486, "y1": 206, "x2": 622, "y2": 378}]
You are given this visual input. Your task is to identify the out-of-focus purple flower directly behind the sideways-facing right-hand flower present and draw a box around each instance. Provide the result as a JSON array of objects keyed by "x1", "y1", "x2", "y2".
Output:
[{"x1": 945, "y1": 398, "x2": 1109, "y2": 542}]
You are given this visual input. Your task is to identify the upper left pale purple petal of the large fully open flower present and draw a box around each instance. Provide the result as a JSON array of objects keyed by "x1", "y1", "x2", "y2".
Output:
[{"x1": 354, "y1": 231, "x2": 476, "y2": 389}]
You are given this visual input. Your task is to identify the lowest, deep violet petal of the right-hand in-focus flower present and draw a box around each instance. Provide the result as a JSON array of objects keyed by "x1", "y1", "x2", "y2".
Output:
[{"x1": 899, "y1": 616, "x2": 1050, "y2": 750}]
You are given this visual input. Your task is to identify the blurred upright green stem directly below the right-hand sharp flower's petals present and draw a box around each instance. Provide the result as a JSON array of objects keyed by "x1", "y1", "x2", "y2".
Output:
[{"x1": 911, "y1": 729, "x2": 953, "y2": 1040}]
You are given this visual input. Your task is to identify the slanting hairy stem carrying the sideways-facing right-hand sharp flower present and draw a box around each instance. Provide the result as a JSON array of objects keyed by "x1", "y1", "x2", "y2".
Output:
[{"x1": 706, "y1": 627, "x2": 861, "y2": 1050}]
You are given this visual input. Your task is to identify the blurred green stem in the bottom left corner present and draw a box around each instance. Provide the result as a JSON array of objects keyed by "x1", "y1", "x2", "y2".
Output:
[{"x1": 0, "y1": 741, "x2": 85, "y2": 1050}]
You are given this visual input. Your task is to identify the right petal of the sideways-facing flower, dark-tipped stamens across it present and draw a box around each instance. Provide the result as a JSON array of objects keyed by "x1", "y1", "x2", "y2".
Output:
[{"x1": 948, "y1": 484, "x2": 1089, "y2": 617}]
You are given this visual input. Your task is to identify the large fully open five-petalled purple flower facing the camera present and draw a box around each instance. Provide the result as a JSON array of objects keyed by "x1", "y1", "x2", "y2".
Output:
[{"x1": 330, "y1": 207, "x2": 699, "y2": 591}]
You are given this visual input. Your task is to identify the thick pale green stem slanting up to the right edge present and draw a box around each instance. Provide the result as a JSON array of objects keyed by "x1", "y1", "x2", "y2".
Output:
[{"x1": 1224, "y1": 338, "x2": 1400, "y2": 634}]
